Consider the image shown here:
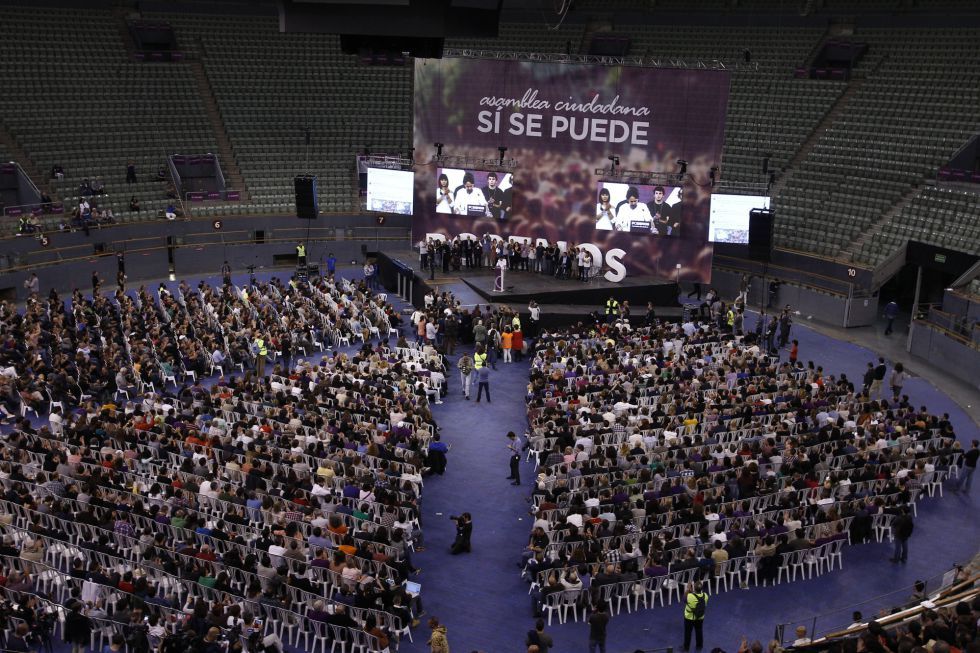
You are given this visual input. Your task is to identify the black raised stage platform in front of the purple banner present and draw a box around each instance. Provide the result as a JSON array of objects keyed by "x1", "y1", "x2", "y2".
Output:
[{"x1": 369, "y1": 249, "x2": 680, "y2": 315}]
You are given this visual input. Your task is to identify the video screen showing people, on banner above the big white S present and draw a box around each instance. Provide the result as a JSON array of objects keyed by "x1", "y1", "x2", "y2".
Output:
[{"x1": 595, "y1": 181, "x2": 684, "y2": 237}]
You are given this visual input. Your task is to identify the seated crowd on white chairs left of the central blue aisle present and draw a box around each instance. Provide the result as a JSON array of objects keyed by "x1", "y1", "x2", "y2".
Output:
[{"x1": 0, "y1": 268, "x2": 447, "y2": 651}]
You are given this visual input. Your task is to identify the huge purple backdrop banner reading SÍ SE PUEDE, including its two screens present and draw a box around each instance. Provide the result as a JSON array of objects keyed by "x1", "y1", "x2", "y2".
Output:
[{"x1": 413, "y1": 58, "x2": 729, "y2": 282}]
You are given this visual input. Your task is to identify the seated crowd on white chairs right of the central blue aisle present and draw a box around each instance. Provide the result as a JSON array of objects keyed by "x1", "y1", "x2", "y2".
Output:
[{"x1": 521, "y1": 312, "x2": 962, "y2": 616}]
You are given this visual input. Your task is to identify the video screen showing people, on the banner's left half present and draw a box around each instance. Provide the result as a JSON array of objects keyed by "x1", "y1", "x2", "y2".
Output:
[{"x1": 433, "y1": 168, "x2": 514, "y2": 222}]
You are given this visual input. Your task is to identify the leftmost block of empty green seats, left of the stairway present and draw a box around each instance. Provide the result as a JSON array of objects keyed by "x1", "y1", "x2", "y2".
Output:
[{"x1": 0, "y1": 7, "x2": 216, "y2": 233}]
